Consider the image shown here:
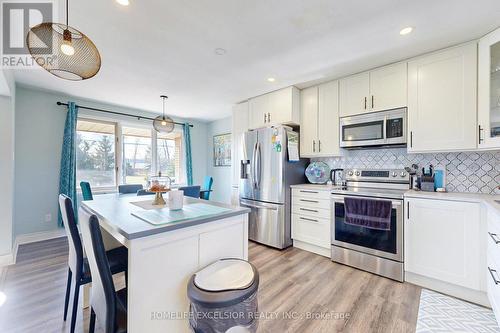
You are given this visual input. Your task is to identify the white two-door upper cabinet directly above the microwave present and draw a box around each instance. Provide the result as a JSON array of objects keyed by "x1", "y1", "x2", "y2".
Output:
[{"x1": 340, "y1": 63, "x2": 407, "y2": 117}]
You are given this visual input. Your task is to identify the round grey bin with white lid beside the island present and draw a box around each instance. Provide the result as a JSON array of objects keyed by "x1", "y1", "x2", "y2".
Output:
[{"x1": 187, "y1": 259, "x2": 259, "y2": 333}]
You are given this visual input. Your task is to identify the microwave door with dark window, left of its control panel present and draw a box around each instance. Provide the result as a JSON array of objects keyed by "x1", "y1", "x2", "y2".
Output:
[{"x1": 340, "y1": 114, "x2": 386, "y2": 147}]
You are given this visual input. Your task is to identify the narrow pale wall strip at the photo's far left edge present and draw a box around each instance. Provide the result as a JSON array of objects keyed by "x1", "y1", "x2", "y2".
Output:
[{"x1": 0, "y1": 70, "x2": 16, "y2": 260}]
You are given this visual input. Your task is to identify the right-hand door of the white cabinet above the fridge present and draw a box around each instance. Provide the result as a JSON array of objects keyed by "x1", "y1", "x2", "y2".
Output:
[{"x1": 267, "y1": 87, "x2": 300, "y2": 125}]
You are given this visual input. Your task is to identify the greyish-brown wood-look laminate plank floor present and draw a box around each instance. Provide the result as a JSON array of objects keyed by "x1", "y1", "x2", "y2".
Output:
[{"x1": 0, "y1": 238, "x2": 421, "y2": 333}]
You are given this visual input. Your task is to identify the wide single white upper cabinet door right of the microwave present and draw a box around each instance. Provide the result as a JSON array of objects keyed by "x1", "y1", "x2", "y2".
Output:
[{"x1": 408, "y1": 43, "x2": 477, "y2": 152}]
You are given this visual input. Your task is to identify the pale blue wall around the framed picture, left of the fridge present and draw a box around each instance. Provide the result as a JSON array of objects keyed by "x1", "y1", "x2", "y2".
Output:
[{"x1": 207, "y1": 117, "x2": 231, "y2": 204}]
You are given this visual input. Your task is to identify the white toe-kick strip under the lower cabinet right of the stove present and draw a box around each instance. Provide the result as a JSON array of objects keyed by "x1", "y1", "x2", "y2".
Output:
[{"x1": 405, "y1": 272, "x2": 491, "y2": 308}]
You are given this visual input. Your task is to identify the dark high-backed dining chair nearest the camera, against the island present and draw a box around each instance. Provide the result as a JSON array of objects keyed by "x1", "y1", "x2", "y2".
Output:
[{"x1": 79, "y1": 208, "x2": 127, "y2": 333}]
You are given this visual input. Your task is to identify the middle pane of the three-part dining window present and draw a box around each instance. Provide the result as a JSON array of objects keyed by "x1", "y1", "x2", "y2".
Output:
[{"x1": 122, "y1": 127, "x2": 152, "y2": 185}]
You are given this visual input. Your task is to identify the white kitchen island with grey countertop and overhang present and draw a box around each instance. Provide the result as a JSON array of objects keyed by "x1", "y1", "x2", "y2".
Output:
[{"x1": 81, "y1": 194, "x2": 249, "y2": 333}]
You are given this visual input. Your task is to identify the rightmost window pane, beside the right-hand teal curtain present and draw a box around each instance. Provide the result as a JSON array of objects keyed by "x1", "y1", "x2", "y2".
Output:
[{"x1": 157, "y1": 133, "x2": 181, "y2": 183}]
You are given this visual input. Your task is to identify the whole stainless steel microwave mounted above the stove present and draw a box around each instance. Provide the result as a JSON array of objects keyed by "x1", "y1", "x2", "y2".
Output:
[{"x1": 340, "y1": 108, "x2": 407, "y2": 148}]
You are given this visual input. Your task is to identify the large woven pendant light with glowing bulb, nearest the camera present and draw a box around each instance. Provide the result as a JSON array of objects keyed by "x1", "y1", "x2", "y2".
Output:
[{"x1": 26, "y1": 0, "x2": 101, "y2": 81}]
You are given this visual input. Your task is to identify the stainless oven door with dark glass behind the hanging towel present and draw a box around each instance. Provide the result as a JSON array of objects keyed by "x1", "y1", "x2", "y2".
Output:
[{"x1": 331, "y1": 195, "x2": 403, "y2": 261}]
